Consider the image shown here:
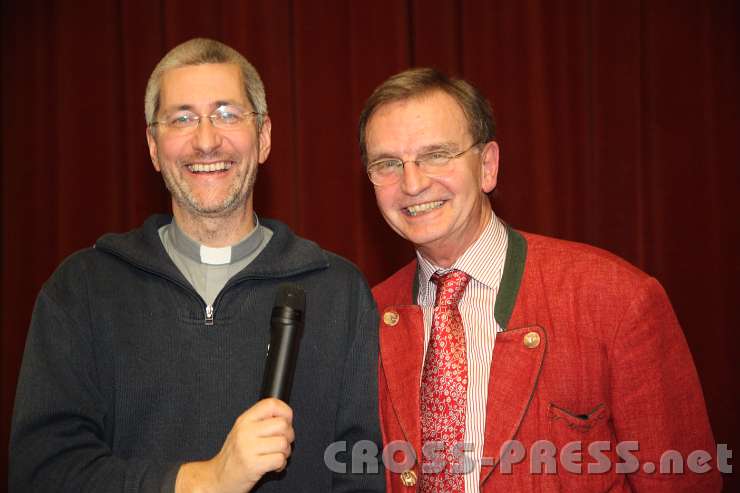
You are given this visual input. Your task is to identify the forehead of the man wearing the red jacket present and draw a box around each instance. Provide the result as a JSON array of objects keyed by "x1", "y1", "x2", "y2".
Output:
[{"x1": 365, "y1": 91, "x2": 469, "y2": 153}]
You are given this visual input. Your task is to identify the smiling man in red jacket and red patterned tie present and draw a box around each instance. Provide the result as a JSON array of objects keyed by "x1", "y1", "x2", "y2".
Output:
[{"x1": 359, "y1": 69, "x2": 720, "y2": 493}]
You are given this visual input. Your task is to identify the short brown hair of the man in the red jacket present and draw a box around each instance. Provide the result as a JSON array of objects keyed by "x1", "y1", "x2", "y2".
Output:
[{"x1": 359, "y1": 68, "x2": 496, "y2": 166}]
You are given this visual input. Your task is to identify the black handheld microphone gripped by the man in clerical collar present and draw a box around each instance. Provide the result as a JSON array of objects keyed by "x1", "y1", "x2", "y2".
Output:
[{"x1": 260, "y1": 283, "x2": 306, "y2": 402}]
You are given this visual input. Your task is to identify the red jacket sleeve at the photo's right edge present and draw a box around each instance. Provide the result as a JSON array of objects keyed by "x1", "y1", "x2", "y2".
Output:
[{"x1": 609, "y1": 278, "x2": 722, "y2": 493}]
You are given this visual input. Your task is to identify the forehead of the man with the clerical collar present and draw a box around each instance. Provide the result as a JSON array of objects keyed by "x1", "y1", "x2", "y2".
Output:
[{"x1": 160, "y1": 63, "x2": 246, "y2": 108}]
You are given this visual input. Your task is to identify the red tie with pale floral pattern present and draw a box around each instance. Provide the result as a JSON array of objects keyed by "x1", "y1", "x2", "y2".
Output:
[{"x1": 421, "y1": 270, "x2": 470, "y2": 493}]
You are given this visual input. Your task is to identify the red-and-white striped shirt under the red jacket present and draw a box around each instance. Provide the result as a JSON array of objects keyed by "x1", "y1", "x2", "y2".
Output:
[{"x1": 416, "y1": 213, "x2": 508, "y2": 493}]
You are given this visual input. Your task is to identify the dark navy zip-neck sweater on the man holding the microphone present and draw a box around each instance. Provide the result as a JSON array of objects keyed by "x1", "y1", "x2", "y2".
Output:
[{"x1": 9, "y1": 216, "x2": 383, "y2": 493}]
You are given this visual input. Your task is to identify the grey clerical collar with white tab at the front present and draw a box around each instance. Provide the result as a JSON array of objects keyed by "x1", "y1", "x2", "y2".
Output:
[{"x1": 167, "y1": 214, "x2": 264, "y2": 265}]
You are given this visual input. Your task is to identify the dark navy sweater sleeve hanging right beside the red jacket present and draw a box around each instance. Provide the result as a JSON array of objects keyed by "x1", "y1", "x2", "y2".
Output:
[{"x1": 332, "y1": 288, "x2": 385, "y2": 492}]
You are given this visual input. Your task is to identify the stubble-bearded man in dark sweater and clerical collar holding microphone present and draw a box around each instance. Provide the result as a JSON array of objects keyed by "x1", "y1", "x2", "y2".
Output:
[{"x1": 10, "y1": 39, "x2": 383, "y2": 493}]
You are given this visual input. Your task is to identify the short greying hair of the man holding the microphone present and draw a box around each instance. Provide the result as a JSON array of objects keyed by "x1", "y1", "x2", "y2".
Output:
[{"x1": 144, "y1": 38, "x2": 267, "y2": 129}]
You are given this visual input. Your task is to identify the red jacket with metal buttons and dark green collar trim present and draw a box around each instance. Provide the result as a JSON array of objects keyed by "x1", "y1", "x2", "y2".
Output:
[{"x1": 373, "y1": 229, "x2": 721, "y2": 493}]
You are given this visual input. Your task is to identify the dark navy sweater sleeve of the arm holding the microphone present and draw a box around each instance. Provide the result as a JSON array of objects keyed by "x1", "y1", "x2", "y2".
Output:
[{"x1": 8, "y1": 288, "x2": 179, "y2": 493}]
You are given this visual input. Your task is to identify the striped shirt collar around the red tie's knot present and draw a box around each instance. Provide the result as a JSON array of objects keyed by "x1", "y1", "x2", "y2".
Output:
[{"x1": 416, "y1": 211, "x2": 507, "y2": 303}]
